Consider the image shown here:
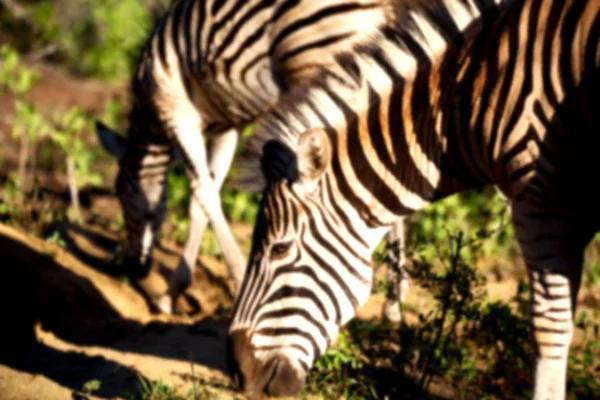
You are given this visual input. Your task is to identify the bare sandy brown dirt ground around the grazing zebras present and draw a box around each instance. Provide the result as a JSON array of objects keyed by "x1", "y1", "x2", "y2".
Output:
[{"x1": 0, "y1": 62, "x2": 598, "y2": 400}]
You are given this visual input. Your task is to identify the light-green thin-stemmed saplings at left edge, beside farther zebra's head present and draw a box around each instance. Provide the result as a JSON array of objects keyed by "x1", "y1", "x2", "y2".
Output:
[{"x1": 0, "y1": 46, "x2": 100, "y2": 231}]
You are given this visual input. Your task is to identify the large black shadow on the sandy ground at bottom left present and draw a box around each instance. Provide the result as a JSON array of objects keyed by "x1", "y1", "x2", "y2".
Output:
[{"x1": 0, "y1": 235, "x2": 229, "y2": 397}]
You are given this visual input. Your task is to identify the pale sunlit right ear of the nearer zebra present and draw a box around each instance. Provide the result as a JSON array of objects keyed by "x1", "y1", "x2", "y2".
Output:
[{"x1": 298, "y1": 128, "x2": 332, "y2": 183}]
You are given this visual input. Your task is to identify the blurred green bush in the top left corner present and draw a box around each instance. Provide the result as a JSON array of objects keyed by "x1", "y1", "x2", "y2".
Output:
[{"x1": 0, "y1": 0, "x2": 155, "y2": 82}]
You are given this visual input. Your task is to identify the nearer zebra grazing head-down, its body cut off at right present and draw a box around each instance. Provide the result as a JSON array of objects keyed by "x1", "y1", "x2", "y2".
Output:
[{"x1": 227, "y1": 0, "x2": 600, "y2": 400}]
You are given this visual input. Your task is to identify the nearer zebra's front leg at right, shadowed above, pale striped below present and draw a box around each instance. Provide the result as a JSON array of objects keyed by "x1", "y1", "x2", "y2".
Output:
[{"x1": 512, "y1": 204, "x2": 591, "y2": 400}]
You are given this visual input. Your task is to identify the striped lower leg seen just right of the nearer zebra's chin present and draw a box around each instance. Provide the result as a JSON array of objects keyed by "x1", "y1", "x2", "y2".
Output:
[{"x1": 383, "y1": 217, "x2": 409, "y2": 322}]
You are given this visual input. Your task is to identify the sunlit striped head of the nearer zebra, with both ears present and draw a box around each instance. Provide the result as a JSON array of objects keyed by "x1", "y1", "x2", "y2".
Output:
[{"x1": 228, "y1": 128, "x2": 382, "y2": 397}]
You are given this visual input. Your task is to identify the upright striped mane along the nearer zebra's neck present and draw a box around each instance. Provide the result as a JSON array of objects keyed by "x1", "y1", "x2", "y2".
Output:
[{"x1": 229, "y1": 0, "x2": 510, "y2": 193}]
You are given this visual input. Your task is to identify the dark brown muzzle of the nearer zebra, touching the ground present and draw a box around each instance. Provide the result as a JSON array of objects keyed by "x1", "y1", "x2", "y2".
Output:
[{"x1": 227, "y1": 330, "x2": 306, "y2": 399}]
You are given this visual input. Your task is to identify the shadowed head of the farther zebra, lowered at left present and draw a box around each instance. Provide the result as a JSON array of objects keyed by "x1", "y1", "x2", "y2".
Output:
[{"x1": 96, "y1": 121, "x2": 172, "y2": 278}]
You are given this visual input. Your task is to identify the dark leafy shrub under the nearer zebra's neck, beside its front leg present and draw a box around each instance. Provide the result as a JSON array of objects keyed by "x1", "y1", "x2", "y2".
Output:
[{"x1": 340, "y1": 223, "x2": 533, "y2": 398}]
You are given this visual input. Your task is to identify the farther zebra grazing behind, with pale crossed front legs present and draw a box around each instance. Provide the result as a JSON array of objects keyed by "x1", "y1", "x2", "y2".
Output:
[{"x1": 96, "y1": 0, "x2": 410, "y2": 321}]
